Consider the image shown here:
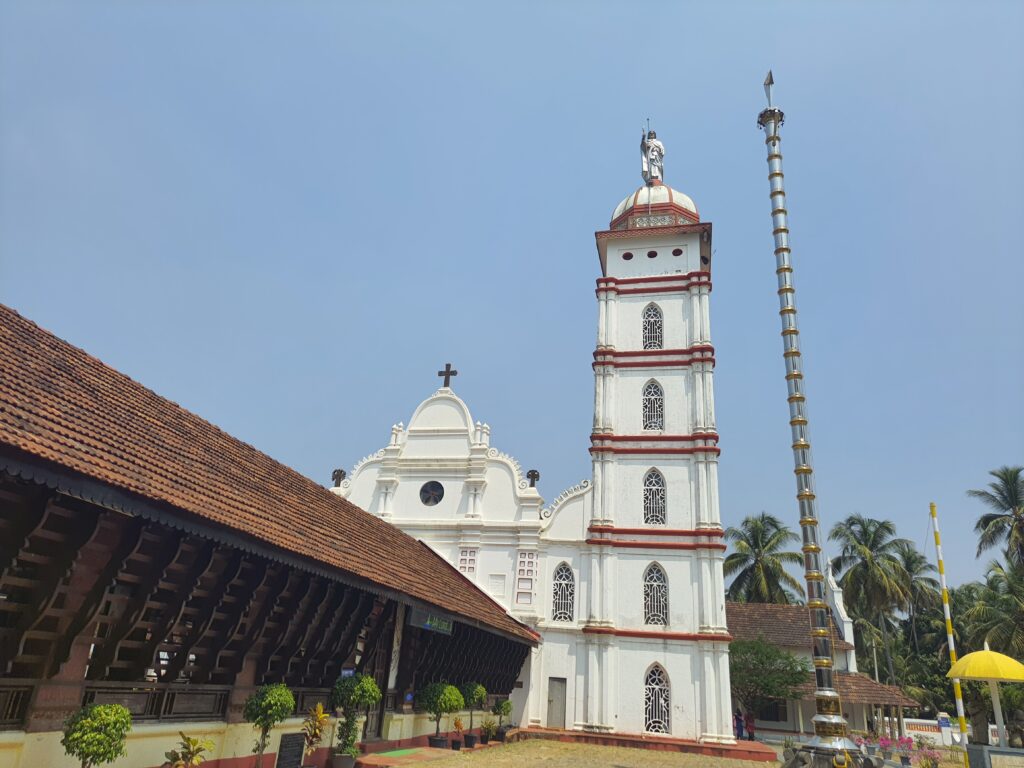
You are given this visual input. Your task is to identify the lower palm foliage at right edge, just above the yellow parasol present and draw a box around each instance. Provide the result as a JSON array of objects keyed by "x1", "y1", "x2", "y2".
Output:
[{"x1": 964, "y1": 562, "x2": 1024, "y2": 658}]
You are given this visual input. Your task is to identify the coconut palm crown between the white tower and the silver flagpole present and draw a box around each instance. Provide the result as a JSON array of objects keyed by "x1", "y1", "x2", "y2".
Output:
[{"x1": 725, "y1": 512, "x2": 804, "y2": 605}]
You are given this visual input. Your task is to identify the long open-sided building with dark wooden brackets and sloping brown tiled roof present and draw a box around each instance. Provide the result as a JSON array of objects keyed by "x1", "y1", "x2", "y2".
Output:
[{"x1": 0, "y1": 306, "x2": 539, "y2": 768}]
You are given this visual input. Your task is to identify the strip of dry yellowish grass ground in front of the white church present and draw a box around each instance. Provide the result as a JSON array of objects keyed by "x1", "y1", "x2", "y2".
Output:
[{"x1": 424, "y1": 739, "x2": 772, "y2": 768}]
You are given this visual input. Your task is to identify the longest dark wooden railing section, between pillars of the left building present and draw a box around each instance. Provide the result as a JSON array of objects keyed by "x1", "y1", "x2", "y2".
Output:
[{"x1": 82, "y1": 683, "x2": 231, "y2": 722}]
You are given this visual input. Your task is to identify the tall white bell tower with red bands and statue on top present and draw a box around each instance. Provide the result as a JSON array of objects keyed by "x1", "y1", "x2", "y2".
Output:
[{"x1": 584, "y1": 132, "x2": 732, "y2": 741}]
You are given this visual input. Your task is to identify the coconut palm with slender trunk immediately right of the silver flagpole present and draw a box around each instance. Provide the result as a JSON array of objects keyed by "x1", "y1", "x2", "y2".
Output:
[{"x1": 828, "y1": 514, "x2": 913, "y2": 684}]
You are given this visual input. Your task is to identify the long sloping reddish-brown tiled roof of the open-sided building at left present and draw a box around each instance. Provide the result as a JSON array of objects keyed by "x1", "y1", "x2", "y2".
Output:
[{"x1": 0, "y1": 304, "x2": 537, "y2": 643}]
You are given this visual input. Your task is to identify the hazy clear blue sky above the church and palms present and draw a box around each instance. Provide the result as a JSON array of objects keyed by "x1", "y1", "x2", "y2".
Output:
[{"x1": 0, "y1": 0, "x2": 1024, "y2": 583}]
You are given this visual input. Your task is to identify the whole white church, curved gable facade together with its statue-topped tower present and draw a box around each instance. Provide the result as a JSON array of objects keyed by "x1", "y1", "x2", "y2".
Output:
[{"x1": 335, "y1": 138, "x2": 734, "y2": 742}]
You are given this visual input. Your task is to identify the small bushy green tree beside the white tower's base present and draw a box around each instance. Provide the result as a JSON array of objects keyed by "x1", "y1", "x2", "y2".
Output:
[{"x1": 729, "y1": 637, "x2": 811, "y2": 713}]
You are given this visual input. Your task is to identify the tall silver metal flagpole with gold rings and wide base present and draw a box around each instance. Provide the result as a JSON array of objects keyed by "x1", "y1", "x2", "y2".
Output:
[{"x1": 758, "y1": 72, "x2": 860, "y2": 766}]
